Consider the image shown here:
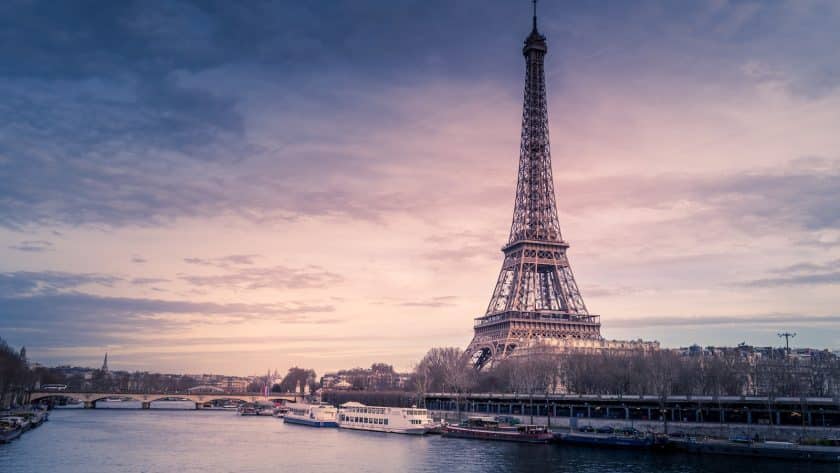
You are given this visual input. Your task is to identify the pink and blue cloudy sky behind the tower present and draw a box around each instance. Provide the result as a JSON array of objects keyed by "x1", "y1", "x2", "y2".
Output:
[{"x1": 0, "y1": 0, "x2": 840, "y2": 374}]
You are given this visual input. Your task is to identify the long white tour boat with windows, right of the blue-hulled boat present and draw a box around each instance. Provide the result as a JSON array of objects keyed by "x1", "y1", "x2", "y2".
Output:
[{"x1": 338, "y1": 402, "x2": 437, "y2": 435}]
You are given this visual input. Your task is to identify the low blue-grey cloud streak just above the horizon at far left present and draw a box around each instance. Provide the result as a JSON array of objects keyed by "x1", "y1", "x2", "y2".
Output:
[{"x1": 0, "y1": 271, "x2": 335, "y2": 346}]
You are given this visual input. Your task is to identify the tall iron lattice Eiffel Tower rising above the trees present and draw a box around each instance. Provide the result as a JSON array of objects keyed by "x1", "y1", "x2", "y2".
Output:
[{"x1": 467, "y1": 9, "x2": 601, "y2": 368}]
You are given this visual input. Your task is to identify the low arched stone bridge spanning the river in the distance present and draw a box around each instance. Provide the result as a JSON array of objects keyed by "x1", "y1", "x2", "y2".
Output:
[{"x1": 29, "y1": 391, "x2": 303, "y2": 409}]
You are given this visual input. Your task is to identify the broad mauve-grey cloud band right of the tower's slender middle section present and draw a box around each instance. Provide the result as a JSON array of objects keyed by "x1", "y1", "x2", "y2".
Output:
[{"x1": 558, "y1": 158, "x2": 840, "y2": 234}]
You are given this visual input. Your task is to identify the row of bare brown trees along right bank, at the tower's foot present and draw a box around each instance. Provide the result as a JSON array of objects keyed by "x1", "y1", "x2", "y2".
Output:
[{"x1": 406, "y1": 348, "x2": 840, "y2": 397}]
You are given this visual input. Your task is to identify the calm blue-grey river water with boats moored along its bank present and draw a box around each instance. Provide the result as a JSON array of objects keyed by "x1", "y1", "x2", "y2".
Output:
[{"x1": 0, "y1": 402, "x2": 840, "y2": 473}]
